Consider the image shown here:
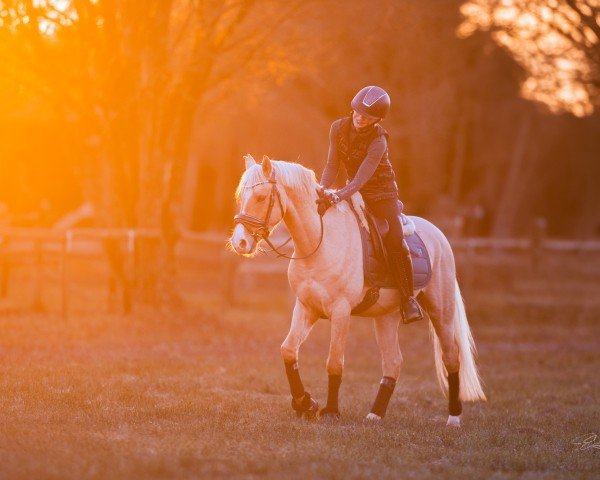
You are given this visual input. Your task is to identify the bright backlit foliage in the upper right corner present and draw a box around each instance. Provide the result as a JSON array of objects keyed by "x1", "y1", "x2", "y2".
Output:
[{"x1": 458, "y1": 0, "x2": 600, "y2": 116}]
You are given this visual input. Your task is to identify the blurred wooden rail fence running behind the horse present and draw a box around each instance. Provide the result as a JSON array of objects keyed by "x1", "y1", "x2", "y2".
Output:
[{"x1": 0, "y1": 228, "x2": 600, "y2": 317}]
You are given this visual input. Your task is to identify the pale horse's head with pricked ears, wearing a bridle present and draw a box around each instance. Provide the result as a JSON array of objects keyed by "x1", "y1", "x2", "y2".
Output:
[{"x1": 230, "y1": 155, "x2": 286, "y2": 255}]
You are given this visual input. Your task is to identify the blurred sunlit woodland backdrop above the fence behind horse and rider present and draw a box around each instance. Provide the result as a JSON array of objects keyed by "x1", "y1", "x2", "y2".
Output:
[{"x1": 0, "y1": 0, "x2": 600, "y2": 237}]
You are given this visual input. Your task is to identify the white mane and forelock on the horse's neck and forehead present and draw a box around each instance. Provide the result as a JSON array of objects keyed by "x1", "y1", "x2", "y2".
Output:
[{"x1": 235, "y1": 160, "x2": 317, "y2": 201}]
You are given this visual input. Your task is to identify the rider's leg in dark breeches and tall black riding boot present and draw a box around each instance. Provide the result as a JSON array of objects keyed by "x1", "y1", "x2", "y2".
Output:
[{"x1": 369, "y1": 199, "x2": 424, "y2": 323}]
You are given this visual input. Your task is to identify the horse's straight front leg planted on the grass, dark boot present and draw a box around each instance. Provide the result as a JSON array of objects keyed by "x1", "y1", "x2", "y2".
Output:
[{"x1": 319, "y1": 302, "x2": 350, "y2": 420}]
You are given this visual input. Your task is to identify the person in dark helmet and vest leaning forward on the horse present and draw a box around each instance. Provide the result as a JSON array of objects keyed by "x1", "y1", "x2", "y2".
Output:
[{"x1": 317, "y1": 86, "x2": 423, "y2": 323}]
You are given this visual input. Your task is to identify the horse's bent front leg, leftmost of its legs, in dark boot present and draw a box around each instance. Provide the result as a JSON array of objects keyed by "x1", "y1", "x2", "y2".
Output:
[{"x1": 281, "y1": 299, "x2": 319, "y2": 418}]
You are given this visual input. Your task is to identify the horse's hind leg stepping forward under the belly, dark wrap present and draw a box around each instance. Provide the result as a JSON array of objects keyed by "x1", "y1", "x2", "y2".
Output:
[{"x1": 367, "y1": 313, "x2": 402, "y2": 420}]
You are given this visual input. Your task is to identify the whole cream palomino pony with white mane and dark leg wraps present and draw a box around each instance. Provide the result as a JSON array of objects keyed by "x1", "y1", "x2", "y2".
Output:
[{"x1": 230, "y1": 155, "x2": 485, "y2": 426}]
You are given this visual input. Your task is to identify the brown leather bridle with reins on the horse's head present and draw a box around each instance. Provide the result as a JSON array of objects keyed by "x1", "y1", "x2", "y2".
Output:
[{"x1": 233, "y1": 170, "x2": 323, "y2": 260}]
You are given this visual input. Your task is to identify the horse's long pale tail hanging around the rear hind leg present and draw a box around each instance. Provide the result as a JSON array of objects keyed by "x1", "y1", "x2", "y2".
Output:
[{"x1": 429, "y1": 281, "x2": 486, "y2": 402}]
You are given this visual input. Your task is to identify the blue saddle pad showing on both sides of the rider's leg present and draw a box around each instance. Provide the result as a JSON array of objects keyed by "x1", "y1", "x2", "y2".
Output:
[{"x1": 360, "y1": 220, "x2": 431, "y2": 290}]
